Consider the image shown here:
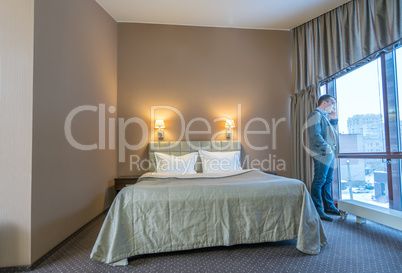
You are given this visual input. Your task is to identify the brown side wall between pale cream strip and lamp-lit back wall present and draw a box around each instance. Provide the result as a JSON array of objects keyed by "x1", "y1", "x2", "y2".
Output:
[{"x1": 32, "y1": 0, "x2": 117, "y2": 261}]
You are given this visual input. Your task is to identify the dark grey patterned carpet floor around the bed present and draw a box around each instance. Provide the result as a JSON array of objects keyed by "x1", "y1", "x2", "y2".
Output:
[{"x1": 0, "y1": 210, "x2": 402, "y2": 273}]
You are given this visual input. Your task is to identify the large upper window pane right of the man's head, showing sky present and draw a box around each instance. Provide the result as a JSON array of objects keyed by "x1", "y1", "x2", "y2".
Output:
[{"x1": 336, "y1": 59, "x2": 385, "y2": 153}]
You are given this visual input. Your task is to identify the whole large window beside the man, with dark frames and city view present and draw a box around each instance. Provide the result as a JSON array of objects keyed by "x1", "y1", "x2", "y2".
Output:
[{"x1": 327, "y1": 48, "x2": 402, "y2": 210}]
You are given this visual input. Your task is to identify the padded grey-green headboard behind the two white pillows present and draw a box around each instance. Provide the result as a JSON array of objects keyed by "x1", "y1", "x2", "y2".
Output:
[{"x1": 148, "y1": 140, "x2": 241, "y2": 173}]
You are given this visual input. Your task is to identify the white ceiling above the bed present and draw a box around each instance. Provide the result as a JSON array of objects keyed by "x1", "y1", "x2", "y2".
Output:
[{"x1": 96, "y1": 0, "x2": 350, "y2": 30}]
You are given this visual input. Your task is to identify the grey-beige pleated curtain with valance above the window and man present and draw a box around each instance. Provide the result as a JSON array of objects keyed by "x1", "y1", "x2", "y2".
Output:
[{"x1": 291, "y1": 0, "x2": 402, "y2": 186}]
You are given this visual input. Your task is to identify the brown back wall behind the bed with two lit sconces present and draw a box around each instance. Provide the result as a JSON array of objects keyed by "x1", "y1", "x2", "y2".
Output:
[{"x1": 117, "y1": 23, "x2": 291, "y2": 176}]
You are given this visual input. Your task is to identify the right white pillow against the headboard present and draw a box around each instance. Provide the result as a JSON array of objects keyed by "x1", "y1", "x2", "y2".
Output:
[{"x1": 198, "y1": 150, "x2": 242, "y2": 173}]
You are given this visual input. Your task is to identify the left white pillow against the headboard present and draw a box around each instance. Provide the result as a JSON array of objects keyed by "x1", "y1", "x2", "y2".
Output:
[{"x1": 155, "y1": 152, "x2": 198, "y2": 174}]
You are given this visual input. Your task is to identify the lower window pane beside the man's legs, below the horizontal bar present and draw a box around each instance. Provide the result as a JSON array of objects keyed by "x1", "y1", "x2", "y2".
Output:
[{"x1": 340, "y1": 158, "x2": 389, "y2": 208}]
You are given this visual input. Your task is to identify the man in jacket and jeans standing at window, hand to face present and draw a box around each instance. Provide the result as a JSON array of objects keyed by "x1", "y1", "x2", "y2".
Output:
[{"x1": 307, "y1": 95, "x2": 340, "y2": 221}]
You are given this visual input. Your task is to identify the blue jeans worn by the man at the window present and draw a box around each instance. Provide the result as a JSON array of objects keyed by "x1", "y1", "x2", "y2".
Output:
[{"x1": 311, "y1": 155, "x2": 335, "y2": 211}]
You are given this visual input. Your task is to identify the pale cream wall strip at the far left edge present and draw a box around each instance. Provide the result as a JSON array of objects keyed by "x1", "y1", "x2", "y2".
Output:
[{"x1": 0, "y1": 0, "x2": 34, "y2": 267}]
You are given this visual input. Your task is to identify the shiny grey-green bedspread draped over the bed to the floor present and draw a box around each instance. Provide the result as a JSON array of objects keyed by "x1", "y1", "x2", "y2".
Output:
[{"x1": 91, "y1": 170, "x2": 327, "y2": 265}]
